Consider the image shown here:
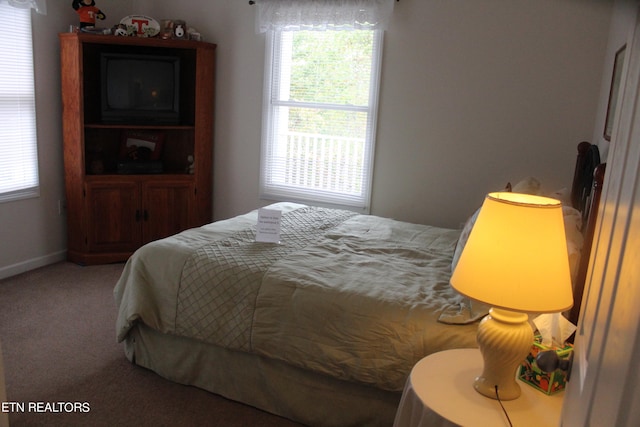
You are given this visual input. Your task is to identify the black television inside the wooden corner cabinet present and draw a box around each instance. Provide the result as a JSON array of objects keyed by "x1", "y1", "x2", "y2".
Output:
[{"x1": 100, "y1": 53, "x2": 180, "y2": 124}]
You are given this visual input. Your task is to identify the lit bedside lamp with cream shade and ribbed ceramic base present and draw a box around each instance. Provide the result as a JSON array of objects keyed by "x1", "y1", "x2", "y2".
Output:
[{"x1": 451, "y1": 192, "x2": 573, "y2": 400}]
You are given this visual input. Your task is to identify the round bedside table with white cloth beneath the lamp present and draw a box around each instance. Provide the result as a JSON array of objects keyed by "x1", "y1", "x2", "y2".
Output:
[{"x1": 393, "y1": 349, "x2": 564, "y2": 427}]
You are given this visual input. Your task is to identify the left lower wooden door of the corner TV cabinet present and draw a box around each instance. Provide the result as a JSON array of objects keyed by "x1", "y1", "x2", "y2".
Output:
[{"x1": 85, "y1": 181, "x2": 142, "y2": 252}]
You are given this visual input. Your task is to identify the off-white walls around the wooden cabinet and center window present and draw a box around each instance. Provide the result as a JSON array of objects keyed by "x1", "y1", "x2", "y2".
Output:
[{"x1": 0, "y1": 0, "x2": 611, "y2": 277}]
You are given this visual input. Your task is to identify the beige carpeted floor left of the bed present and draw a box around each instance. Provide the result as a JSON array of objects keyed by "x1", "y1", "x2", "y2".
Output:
[{"x1": 0, "y1": 263, "x2": 299, "y2": 427}]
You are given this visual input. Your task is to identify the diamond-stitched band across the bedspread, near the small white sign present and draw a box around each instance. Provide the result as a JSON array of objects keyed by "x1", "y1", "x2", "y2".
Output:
[{"x1": 176, "y1": 207, "x2": 355, "y2": 351}]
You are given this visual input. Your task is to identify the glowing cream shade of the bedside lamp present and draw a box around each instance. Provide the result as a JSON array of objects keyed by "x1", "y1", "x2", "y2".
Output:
[{"x1": 451, "y1": 193, "x2": 573, "y2": 313}]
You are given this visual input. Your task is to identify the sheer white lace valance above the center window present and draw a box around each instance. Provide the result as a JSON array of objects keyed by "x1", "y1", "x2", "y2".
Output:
[{"x1": 255, "y1": 0, "x2": 395, "y2": 33}]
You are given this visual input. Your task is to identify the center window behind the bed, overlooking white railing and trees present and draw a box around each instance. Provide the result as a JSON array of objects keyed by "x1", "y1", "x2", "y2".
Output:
[{"x1": 261, "y1": 30, "x2": 383, "y2": 212}]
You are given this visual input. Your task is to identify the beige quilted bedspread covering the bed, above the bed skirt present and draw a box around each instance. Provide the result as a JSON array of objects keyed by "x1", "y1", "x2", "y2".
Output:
[{"x1": 114, "y1": 203, "x2": 477, "y2": 391}]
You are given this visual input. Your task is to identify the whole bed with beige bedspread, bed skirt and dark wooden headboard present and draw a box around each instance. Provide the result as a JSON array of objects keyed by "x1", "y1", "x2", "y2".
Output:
[{"x1": 114, "y1": 143, "x2": 600, "y2": 426}]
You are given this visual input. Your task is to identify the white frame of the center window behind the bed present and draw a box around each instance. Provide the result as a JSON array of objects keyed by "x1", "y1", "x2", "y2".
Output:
[{"x1": 260, "y1": 30, "x2": 384, "y2": 213}]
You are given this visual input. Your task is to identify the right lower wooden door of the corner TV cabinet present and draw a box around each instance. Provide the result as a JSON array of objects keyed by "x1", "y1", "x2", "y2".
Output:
[{"x1": 142, "y1": 180, "x2": 195, "y2": 243}]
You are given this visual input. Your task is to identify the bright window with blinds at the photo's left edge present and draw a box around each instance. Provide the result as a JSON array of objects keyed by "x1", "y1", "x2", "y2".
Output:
[{"x1": 0, "y1": 2, "x2": 39, "y2": 202}]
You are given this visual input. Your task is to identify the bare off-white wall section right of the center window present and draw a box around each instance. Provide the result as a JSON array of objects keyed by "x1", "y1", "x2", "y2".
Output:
[{"x1": 373, "y1": 0, "x2": 610, "y2": 227}]
